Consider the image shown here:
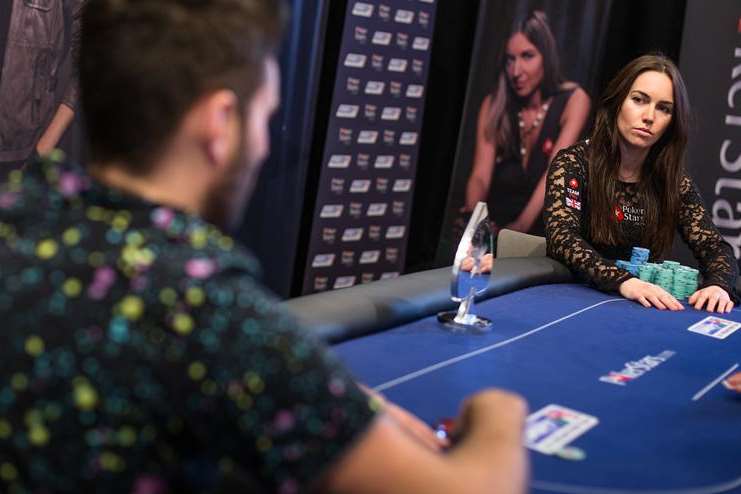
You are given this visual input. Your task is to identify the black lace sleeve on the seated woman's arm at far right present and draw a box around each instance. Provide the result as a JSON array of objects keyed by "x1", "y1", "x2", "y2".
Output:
[{"x1": 678, "y1": 176, "x2": 738, "y2": 302}]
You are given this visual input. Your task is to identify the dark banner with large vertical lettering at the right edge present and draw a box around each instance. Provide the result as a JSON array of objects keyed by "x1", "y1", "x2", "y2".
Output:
[{"x1": 675, "y1": 0, "x2": 741, "y2": 270}]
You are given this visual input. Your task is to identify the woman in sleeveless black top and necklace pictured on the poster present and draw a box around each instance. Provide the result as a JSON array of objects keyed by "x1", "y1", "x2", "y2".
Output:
[{"x1": 463, "y1": 11, "x2": 589, "y2": 235}]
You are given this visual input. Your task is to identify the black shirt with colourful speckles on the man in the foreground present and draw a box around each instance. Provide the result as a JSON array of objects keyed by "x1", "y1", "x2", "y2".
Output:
[{"x1": 0, "y1": 156, "x2": 377, "y2": 494}]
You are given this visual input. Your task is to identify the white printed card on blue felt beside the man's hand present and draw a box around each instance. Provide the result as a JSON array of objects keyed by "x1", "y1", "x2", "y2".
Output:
[{"x1": 525, "y1": 404, "x2": 599, "y2": 455}]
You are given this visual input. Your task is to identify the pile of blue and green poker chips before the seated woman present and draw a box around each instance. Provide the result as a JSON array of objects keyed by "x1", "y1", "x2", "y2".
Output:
[{"x1": 615, "y1": 247, "x2": 700, "y2": 300}]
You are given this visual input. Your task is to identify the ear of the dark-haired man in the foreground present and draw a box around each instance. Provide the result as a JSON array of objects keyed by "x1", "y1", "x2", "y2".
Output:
[{"x1": 198, "y1": 89, "x2": 240, "y2": 167}]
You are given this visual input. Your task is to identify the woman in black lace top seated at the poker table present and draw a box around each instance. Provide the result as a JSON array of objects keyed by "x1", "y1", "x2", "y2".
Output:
[{"x1": 544, "y1": 55, "x2": 738, "y2": 312}]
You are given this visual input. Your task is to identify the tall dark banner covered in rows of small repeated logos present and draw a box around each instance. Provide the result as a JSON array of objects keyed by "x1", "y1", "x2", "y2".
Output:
[{"x1": 302, "y1": 0, "x2": 436, "y2": 294}]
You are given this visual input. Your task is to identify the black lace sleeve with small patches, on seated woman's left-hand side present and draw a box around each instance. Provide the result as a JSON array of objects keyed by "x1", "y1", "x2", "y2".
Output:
[{"x1": 543, "y1": 145, "x2": 633, "y2": 291}]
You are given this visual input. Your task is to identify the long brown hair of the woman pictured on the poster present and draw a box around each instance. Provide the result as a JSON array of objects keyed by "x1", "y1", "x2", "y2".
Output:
[{"x1": 485, "y1": 10, "x2": 564, "y2": 156}]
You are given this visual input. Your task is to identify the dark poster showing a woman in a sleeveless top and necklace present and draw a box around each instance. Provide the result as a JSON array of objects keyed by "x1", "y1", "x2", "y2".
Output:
[{"x1": 438, "y1": 0, "x2": 609, "y2": 258}]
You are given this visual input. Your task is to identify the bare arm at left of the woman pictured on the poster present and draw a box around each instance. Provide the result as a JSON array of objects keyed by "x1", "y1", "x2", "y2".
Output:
[{"x1": 463, "y1": 95, "x2": 497, "y2": 212}]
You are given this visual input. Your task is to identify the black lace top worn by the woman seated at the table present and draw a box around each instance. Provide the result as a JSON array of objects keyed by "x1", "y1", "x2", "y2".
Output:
[{"x1": 544, "y1": 142, "x2": 738, "y2": 298}]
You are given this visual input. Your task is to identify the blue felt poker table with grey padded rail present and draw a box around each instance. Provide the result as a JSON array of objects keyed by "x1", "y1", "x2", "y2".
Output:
[{"x1": 287, "y1": 258, "x2": 741, "y2": 494}]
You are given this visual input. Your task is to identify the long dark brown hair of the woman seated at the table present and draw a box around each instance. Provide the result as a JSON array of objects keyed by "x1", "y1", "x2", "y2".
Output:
[{"x1": 588, "y1": 55, "x2": 690, "y2": 257}]
